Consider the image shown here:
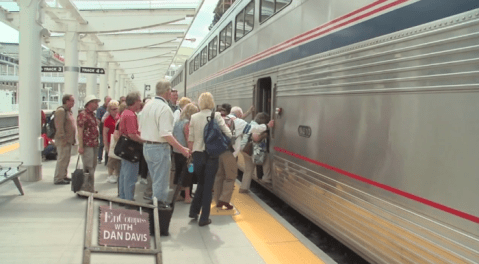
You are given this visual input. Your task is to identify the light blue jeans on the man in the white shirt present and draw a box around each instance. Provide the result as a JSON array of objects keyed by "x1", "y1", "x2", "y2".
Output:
[{"x1": 143, "y1": 143, "x2": 171, "y2": 203}]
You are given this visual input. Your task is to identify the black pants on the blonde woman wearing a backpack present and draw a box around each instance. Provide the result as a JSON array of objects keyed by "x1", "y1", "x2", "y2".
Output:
[{"x1": 190, "y1": 151, "x2": 218, "y2": 223}]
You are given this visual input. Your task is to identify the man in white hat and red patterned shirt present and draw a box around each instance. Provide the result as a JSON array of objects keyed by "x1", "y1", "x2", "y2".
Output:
[{"x1": 77, "y1": 95, "x2": 100, "y2": 192}]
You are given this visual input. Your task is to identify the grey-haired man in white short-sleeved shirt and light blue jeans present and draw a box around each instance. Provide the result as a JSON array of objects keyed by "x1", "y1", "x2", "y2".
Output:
[{"x1": 140, "y1": 80, "x2": 190, "y2": 206}]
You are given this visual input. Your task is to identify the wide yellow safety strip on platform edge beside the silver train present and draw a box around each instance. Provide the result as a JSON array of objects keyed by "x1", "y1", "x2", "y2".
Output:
[{"x1": 232, "y1": 184, "x2": 324, "y2": 264}]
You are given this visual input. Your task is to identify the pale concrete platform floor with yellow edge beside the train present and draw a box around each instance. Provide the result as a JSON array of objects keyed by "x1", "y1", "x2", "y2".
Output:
[{"x1": 0, "y1": 143, "x2": 335, "y2": 264}]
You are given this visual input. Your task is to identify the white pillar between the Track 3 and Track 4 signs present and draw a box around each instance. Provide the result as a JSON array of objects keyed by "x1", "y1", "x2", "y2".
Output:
[{"x1": 63, "y1": 28, "x2": 79, "y2": 116}]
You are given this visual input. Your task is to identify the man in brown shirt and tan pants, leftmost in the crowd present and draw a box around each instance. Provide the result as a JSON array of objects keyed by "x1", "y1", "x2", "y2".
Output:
[{"x1": 53, "y1": 94, "x2": 76, "y2": 184}]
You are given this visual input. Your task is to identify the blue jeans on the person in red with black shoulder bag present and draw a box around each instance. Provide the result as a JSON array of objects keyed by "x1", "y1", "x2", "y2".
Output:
[{"x1": 118, "y1": 159, "x2": 139, "y2": 201}]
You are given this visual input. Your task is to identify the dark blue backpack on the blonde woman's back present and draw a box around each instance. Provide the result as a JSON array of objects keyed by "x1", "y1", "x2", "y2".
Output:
[{"x1": 203, "y1": 110, "x2": 231, "y2": 157}]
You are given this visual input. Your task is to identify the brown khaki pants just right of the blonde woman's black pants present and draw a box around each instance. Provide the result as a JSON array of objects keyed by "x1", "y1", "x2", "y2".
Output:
[{"x1": 214, "y1": 151, "x2": 238, "y2": 203}]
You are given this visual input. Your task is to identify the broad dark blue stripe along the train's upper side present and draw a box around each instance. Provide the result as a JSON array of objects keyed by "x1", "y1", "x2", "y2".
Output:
[{"x1": 197, "y1": 0, "x2": 479, "y2": 86}]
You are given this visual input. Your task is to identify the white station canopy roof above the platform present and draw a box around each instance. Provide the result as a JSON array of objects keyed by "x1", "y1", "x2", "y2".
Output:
[{"x1": 0, "y1": 0, "x2": 203, "y2": 87}]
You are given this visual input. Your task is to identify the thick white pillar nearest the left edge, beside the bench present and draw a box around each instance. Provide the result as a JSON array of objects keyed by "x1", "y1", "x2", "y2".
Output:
[{"x1": 17, "y1": 0, "x2": 43, "y2": 181}]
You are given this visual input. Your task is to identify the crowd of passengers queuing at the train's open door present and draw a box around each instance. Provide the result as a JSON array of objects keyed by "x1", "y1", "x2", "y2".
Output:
[{"x1": 50, "y1": 80, "x2": 274, "y2": 226}]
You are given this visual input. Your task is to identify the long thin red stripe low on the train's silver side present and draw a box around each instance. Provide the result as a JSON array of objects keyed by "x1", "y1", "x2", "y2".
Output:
[{"x1": 274, "y1": 147, "x2": 479, "y2": 223}]
